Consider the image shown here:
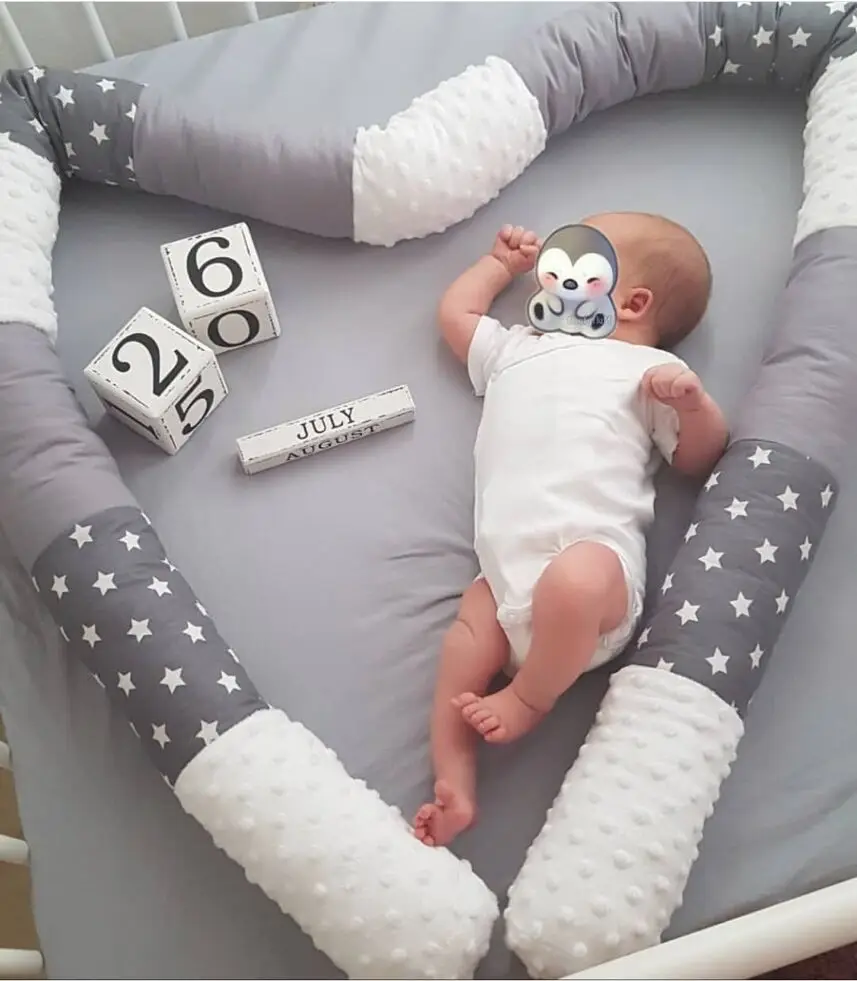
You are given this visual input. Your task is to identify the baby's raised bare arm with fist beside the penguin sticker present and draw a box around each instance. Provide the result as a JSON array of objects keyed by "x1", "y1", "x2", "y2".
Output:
[{"x1": 438, "y1": 225, "x2": 540, "y2": 362}]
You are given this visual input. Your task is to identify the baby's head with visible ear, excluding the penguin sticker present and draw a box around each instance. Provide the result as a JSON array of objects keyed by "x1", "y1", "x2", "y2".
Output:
[{"x1": 581, "y1": 211, "x2": 711, "y2": 348}]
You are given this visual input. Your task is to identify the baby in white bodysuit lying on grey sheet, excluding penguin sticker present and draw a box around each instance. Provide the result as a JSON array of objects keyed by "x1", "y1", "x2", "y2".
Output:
[{"x1": 414, "y1": 213, "x2": 728, "y2": 845}]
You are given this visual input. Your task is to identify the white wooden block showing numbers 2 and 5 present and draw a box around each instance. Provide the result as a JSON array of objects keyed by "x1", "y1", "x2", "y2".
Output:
[{"x1": 84, "y1": 307, "x2": 228, "y2": 454}]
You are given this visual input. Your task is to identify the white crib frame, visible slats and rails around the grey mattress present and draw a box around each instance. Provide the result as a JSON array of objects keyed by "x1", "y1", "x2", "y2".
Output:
[{"x1": 5, "y1": 0, "x2": 857, "y2": 981}]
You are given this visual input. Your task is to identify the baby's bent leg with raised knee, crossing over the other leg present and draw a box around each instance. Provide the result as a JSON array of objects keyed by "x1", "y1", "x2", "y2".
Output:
[{"x1": 456, "y1": 542, "x2": 628, "y2": 743}]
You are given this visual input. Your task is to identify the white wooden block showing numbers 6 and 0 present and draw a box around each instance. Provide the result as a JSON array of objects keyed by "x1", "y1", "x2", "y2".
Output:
[{"x1": 161, "y1": 222, "x2": 280, "y2": 354}]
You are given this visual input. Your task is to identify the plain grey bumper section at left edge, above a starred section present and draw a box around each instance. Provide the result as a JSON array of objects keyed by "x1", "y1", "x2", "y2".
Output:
[{"x1": 0, "y1": 324, "x2": 135, "y2": 569}]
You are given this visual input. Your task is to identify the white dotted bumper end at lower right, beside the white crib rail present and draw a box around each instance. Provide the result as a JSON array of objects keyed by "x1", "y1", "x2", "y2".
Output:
[{"x1": 505, "y1": 665, "x2": 744, "y2": 978}]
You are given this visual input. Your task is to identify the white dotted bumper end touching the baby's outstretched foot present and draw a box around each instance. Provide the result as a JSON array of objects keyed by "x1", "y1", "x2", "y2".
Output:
[{"x1": 175, "y1": 709, "x2": 498, "y2": 978}]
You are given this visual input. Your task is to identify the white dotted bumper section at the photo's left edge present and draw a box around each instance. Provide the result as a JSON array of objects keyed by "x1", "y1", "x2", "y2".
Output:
[{"x1": 0, "y1": 133, "x2": 60, "y2": 340}]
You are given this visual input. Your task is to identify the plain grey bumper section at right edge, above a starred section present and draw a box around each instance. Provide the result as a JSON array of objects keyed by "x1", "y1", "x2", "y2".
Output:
[{"x1": 734, "y1": 228, "x2": 857, "y2": 474}]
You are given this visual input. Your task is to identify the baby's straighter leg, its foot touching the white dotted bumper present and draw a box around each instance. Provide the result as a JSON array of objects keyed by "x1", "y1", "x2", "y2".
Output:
[{"x1": 414, "y1": 579, "x2": 508, "y2": 845}]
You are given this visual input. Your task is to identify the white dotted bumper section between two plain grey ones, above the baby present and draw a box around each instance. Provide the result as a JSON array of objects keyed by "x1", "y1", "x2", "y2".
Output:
[{"x1": 352, "y1": 57, "x2": 547, "y2": 246}]
